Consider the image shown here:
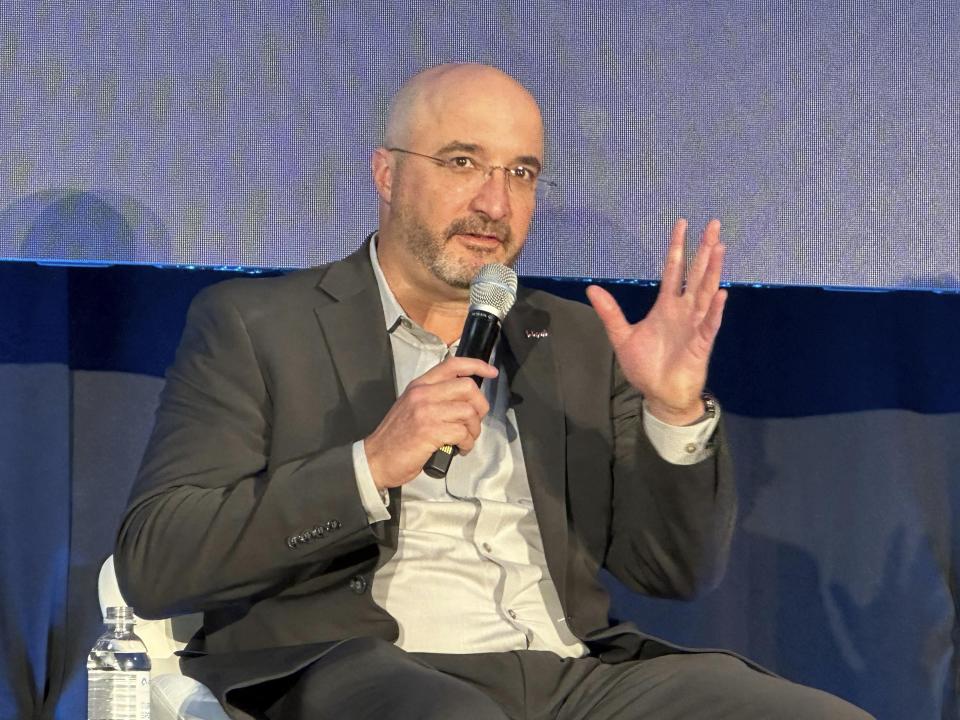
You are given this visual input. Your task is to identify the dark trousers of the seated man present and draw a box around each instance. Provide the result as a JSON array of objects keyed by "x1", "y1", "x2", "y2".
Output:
[{"x1": 247, "y1": 638, "x2": 871, "y2": 720}]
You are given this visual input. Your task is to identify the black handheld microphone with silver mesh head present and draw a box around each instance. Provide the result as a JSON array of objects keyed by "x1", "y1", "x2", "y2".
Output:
[{"x1": 423, "y1": 263, "x2": 517, "y2": 479}]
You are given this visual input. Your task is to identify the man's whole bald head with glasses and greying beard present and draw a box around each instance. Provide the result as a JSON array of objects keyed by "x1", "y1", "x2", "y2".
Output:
[{"x1": 371, "y1": 65, "x2": 543, "y2": 304}]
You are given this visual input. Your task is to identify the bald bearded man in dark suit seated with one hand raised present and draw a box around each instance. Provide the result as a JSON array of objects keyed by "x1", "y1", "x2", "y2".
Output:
[{"x1": 116, "y1": 65, "x2": 865, "y2": 720}]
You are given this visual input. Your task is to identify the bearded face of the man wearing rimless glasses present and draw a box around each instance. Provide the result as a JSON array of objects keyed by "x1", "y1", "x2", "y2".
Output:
[{"x1": 390, "y1": 75, "x2": 543, "y2": 288}]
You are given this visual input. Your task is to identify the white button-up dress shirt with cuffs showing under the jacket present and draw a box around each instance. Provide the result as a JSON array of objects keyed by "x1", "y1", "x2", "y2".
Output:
[{"x1": 353, "y1": 238, "x2": 717, "y2": 657}]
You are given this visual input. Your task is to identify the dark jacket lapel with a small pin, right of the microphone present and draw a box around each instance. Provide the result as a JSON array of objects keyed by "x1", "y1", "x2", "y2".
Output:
[{"x1": 503, "y1": 289, "x2": 567, "y2": 604}]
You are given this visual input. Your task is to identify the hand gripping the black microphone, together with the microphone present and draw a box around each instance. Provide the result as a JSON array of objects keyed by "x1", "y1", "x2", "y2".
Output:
[{"x1": 364, "y1": 264, "x2": 517, "y2": 489}]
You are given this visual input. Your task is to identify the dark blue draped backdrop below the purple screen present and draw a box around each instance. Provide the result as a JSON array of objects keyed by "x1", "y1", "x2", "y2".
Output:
[{"x1": 0, "y1": 258, "x2": 960, "y2": 720}]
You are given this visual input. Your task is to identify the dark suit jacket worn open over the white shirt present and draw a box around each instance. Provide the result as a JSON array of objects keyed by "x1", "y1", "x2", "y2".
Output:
[{"x1": 115, "y1": 245, "x2": 735, "y2": 716}]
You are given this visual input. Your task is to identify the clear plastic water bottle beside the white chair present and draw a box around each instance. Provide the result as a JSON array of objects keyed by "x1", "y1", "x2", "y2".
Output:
[{"x1": 87, "y1": 607, "x2": 150, "y2": 720}]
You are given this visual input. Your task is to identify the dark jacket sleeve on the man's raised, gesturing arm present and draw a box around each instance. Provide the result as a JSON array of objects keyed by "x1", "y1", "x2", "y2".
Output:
[{"x1": 605, "y1": 363, "x2": 737, "y2": 598}]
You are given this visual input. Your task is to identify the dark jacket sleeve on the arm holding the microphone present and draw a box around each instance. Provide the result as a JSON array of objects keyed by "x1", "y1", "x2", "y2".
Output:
[{"x1": 114, "y1": 283, "x2": 376, "y2": 617}]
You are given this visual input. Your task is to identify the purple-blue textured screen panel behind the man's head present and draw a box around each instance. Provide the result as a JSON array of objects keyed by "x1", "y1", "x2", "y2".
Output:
[{"x1": 0, "y1": 0, "x2": 960, "y2": 290}]
